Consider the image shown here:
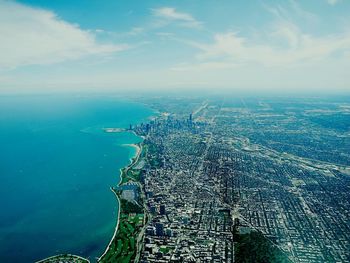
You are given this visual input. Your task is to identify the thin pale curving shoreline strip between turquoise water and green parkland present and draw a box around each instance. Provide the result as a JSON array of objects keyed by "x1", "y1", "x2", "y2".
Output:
[{"x1": 97, "y1": 142, "x2": 143, "y2": 262}]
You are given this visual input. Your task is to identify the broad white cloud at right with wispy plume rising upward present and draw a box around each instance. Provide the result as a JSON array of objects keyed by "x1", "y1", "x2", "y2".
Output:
[{"x1": 180, "y1": 1, "x2": 350, "y2": 69}]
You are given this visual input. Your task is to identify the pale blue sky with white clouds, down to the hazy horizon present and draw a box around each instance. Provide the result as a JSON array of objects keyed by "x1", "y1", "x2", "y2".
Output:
[{"x1": 0, "y1": 0, "x2": 350, "y2": 93}]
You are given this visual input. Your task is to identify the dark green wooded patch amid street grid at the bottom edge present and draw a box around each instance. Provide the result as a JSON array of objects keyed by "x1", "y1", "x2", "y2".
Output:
[{"x1": 235, "y1": 231, "x2": 291, "y2": 263}]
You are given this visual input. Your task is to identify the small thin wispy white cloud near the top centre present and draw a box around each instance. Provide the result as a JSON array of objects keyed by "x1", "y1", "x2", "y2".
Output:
[{"x1": 152, "y1": 7, "x2": 202, "y2": 28}]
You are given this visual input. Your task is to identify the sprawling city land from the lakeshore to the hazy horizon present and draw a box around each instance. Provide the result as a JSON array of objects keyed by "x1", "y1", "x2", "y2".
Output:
[{"x1": 98, "y1": 98, "x2": 350, "y2": 262}]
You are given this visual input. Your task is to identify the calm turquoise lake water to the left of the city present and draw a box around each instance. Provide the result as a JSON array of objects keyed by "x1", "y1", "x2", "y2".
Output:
[{"x1": 0, "y1": 95, "x2": 153, "y2": 262}]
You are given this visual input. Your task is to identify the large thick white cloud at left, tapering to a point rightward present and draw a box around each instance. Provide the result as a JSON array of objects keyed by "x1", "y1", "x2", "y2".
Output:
[{"x1": 0, "y1": 0, "x2": 127, "y2": 68}]
